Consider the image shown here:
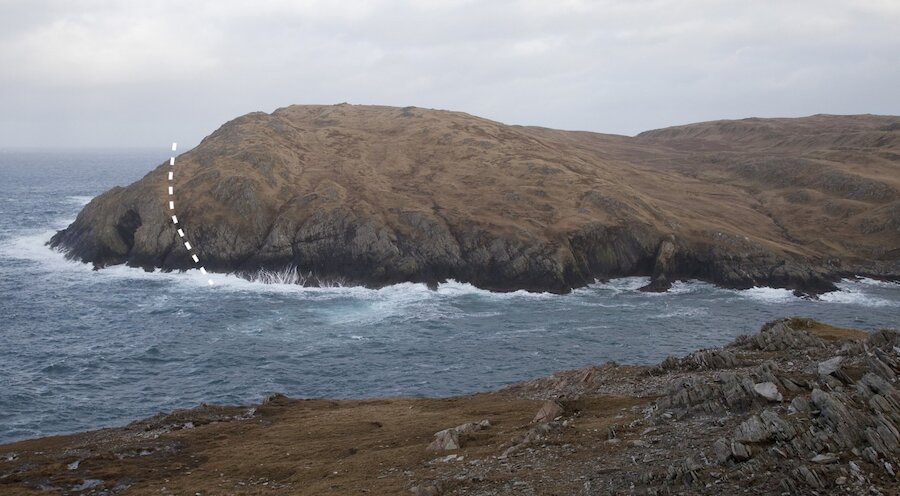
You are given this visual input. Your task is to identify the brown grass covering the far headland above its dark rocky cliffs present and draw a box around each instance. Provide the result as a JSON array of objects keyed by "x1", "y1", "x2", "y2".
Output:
[{"x1": 116, "y1": 105, "x2": 900, "y2": 282}]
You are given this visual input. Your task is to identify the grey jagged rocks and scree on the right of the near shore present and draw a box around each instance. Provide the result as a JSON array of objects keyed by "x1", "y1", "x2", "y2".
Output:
[{"x1": 415, "y1": 319, "x2": 900, "y2": 495}]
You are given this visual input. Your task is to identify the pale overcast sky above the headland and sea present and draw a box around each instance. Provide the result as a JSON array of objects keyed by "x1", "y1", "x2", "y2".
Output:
[{"x1": 0, "y1": 0, "x2": 900, "y2": 149}]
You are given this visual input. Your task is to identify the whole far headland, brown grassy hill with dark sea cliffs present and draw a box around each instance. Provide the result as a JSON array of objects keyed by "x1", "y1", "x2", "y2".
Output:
[{"x1": 51, "y1": 105, "x2": 900, "y2": 292}]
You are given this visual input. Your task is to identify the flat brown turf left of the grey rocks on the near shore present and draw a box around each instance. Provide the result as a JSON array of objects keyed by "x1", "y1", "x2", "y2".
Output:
[{"x1": 0, "y1": 392, "x2": 645, "y2": 495}]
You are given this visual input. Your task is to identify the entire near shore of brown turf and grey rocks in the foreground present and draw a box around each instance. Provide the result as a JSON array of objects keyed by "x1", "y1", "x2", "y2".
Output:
[{"x1": 0, "y1": 318, "x2": 900, "y2": 496}]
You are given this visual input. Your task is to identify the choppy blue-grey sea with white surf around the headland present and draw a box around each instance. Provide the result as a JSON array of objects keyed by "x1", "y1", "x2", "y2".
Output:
[{"x1": 0, "y1": 147, "x2": 900, "y2": 442}]
